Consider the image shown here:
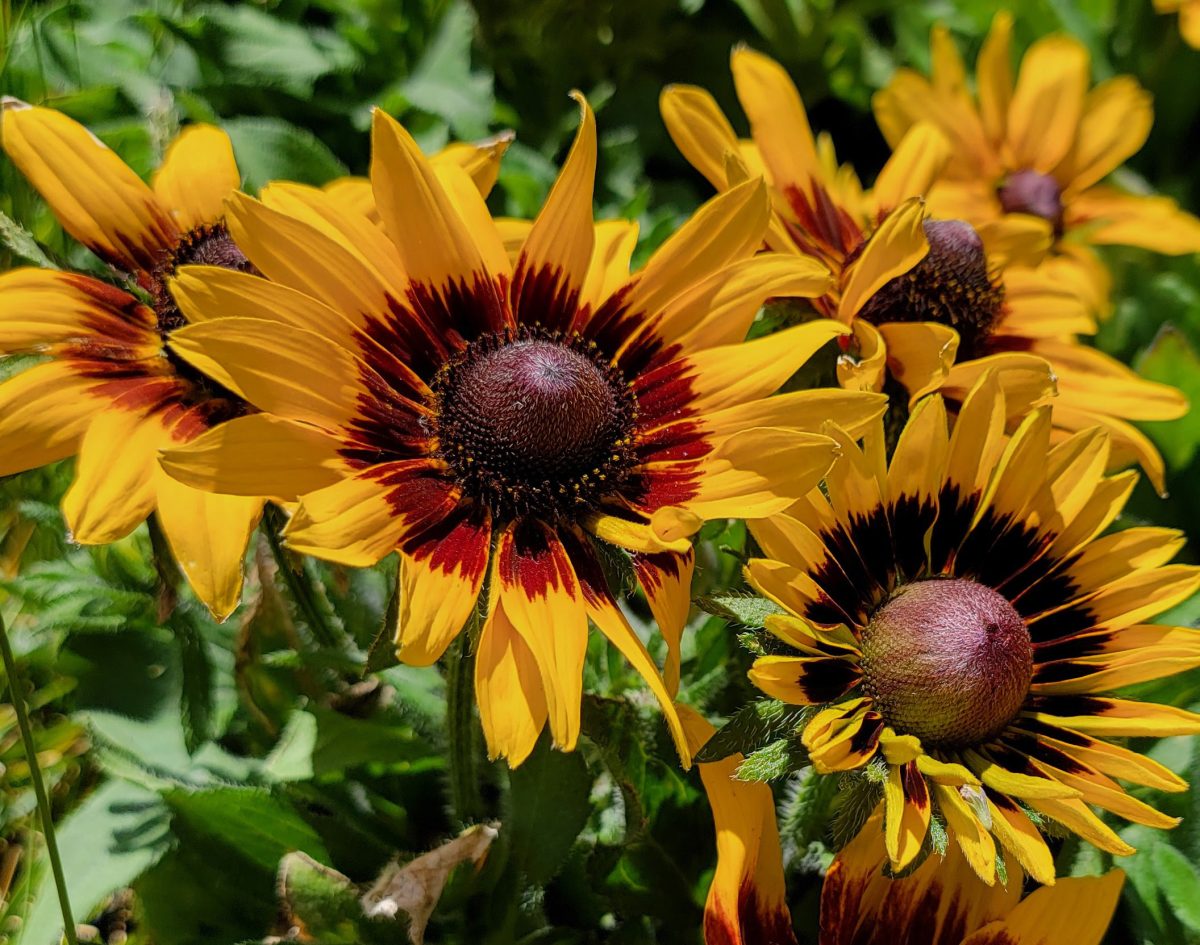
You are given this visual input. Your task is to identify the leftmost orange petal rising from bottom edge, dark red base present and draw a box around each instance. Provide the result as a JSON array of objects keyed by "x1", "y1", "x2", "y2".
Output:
[{"x1": 678, "y1": 705, "x2": 796, "y2": 945}]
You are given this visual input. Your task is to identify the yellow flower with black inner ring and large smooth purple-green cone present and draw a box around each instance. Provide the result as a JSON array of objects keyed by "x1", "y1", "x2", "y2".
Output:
[{"x1": 746, "y1": 374, "x2": 1200, "y2": 883}]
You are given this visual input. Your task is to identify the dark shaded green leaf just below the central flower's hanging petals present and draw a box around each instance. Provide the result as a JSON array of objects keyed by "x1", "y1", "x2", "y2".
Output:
[{"x1": 506, "y1": 734, "x2": 592, "y2": 885}]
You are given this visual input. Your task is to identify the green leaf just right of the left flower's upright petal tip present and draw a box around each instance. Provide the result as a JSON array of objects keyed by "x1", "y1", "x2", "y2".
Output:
[{"x1": 223, "y1": 118, "x2": 347, "y2": 192}]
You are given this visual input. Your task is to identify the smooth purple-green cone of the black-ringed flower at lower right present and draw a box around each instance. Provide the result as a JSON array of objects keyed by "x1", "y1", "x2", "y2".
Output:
[{"x1": 862, "y1": 578, "x2": 1033, "y2": 748}]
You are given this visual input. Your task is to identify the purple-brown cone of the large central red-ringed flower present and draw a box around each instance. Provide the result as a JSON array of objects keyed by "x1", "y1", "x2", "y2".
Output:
[{"x1": 433, "y1": 330, "x2": 636, "y2": 518}]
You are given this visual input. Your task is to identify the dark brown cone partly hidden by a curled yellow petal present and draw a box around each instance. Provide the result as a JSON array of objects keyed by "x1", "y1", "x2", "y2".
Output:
[{"x1": 859, "y1": 219, "x2": 1004, "y2": 361}]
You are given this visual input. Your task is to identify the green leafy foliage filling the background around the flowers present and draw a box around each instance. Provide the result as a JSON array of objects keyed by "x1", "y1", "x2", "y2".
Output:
[{"x1": 0, "y1": 0, "x2": 1200, "y2": 945}]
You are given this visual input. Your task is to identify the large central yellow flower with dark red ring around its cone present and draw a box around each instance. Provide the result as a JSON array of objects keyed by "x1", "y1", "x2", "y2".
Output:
[{"x1": 163, "y1": 97, "x2": 882, "y2": 764}]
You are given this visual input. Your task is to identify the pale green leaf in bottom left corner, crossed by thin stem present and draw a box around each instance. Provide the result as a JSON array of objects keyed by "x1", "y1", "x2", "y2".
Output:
[{"x1": 18, "y1": 781, "x2": 170, "y2": 945}]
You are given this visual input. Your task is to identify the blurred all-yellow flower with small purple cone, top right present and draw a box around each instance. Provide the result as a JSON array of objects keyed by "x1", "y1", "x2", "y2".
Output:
[{"x1": 874, "y1": 12, "x2": 1200, "y2": 308}]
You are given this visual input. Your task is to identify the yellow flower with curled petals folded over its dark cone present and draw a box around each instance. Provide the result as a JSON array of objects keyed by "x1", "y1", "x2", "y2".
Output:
[{"x1": 661, "y1": 49, "x2": 1187, "y2": 490}]
